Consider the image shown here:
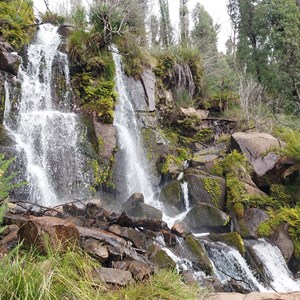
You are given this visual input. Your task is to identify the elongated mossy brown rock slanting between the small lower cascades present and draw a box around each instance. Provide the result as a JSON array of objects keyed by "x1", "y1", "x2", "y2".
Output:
[{"x1": 185, "y1": 234, "x2": 213, "y2": 275}]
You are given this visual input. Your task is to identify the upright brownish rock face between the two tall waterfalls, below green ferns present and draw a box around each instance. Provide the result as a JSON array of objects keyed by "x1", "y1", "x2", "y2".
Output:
[{"x1": 93, "y1": 118, "x2": 117, "y2": 163}]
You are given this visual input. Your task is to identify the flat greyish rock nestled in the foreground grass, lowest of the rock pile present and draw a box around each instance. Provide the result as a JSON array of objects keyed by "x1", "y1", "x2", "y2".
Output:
[{"x1": 93, "y1": 267, "x2": 132, "y2": 286}]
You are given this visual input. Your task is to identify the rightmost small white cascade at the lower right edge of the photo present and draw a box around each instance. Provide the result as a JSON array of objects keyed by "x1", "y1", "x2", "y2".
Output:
[{"x1": 253, "y1": 239, "x2": 300, "y2": 292}]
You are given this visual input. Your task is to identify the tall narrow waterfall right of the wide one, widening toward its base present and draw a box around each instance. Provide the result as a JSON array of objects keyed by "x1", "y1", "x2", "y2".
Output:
[{"x1": 112, "y1": 46, "x2": 158, "y2": 206}]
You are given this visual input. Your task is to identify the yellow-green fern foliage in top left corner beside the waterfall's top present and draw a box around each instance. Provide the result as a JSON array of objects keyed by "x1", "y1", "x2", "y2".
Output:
[{"x1": 0, "y1": 0, "x2": 35, "y2": 50}]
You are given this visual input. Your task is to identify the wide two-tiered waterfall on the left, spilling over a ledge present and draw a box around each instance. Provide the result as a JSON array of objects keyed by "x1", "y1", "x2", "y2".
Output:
[{"x1": 4, "y1": 24, "x2": 89, "y2": 205}]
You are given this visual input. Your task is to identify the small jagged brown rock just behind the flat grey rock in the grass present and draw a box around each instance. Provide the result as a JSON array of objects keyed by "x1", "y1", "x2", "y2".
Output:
[{"x1": 113, "y1": 260, "x2": 153, "y2": 280}]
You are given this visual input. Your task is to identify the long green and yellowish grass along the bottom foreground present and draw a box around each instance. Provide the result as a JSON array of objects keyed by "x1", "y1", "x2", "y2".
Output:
[{"x1": 0, "y1": 245, "x2": 207, "y2": 300}]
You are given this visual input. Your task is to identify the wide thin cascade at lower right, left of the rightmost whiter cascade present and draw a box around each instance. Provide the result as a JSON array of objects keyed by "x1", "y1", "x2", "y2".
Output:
[{"x1": 203, "y1": 241, "x2": 268, "y2": 292}]
